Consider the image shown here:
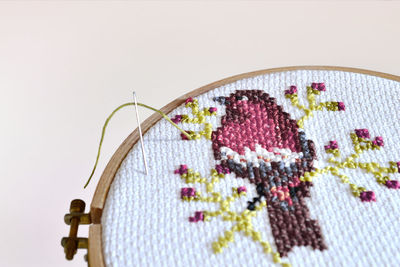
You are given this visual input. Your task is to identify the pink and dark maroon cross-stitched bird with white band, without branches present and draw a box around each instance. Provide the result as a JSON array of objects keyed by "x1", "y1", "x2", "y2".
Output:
[{"x1": 212, "y1": 90, "x2": 326, "y2": 256}]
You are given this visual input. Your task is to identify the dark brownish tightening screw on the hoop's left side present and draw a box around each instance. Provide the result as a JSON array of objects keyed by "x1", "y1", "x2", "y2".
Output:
[{"x1": 61, "y1": 199, "x2": 91, "y2": 260}]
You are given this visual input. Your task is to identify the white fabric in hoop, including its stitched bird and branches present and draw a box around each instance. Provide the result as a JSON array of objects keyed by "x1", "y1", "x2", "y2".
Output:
[{"x1": 102, "y1": 70, "x2": 400, "y2": 266}]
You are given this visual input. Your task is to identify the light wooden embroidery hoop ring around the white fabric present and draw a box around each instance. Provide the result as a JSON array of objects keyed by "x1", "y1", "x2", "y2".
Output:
[{"x1": 64, "y1": 66, "x2": 400, "y2": 267}]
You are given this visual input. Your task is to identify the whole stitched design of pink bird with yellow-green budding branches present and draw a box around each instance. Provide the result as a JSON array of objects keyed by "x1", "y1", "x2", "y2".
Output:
[{"x1": 174, "y1": 83, "x2": 400, "y2": 264}]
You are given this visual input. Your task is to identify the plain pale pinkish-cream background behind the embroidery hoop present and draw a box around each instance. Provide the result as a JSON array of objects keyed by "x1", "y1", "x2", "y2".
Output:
[{"x1": 0, "y1": 1, "x2": 400, "y2": 266}]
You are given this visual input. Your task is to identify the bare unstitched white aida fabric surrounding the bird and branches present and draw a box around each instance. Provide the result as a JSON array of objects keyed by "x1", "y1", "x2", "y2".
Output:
[{"x1": 102, "y1": 70, "x2": 400, "y2": 266}]
